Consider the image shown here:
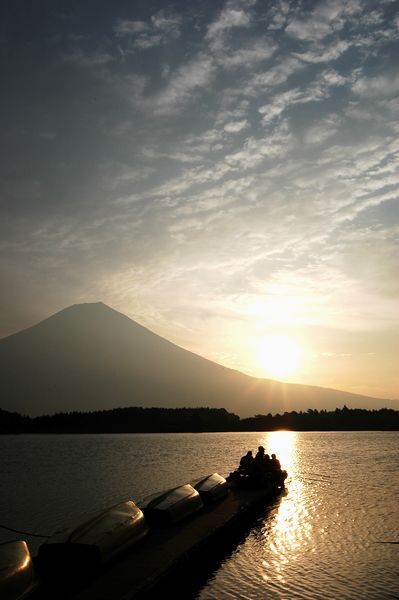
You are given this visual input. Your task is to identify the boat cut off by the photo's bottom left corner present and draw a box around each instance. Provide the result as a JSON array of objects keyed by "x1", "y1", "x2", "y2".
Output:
[{"x1": 0, "y1": 540, "x2": 39, "y2": 600}]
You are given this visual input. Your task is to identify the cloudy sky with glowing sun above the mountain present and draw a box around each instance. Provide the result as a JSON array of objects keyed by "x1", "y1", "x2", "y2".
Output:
[{"x1": 0, "y1": 0, "x2": 399, "y2": 398}]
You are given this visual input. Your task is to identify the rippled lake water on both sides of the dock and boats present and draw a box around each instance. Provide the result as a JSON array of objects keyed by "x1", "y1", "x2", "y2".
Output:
[{"x1": 0, "y1": 432, "x2": 399, "y2": 600}]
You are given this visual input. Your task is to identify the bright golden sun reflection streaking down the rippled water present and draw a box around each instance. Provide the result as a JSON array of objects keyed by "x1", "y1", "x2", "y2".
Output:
[{"x1": 262, "y1": 431, "x2": 315, "y2": 584}]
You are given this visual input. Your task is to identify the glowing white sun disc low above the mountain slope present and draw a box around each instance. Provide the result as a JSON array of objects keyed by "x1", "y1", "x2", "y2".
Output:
[{"x1": 258, "y1": 335, "x2": 303, "y2": 378}]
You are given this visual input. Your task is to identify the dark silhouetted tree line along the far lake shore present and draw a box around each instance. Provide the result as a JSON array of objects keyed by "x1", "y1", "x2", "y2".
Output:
[{"x1": 0, "y1": 406, "x2": 399, "y2": 434}]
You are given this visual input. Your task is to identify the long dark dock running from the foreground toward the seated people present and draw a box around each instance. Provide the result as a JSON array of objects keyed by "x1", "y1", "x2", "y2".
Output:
[{"x1": 36, "y1": 484, "x2": 283, "y2": 600}]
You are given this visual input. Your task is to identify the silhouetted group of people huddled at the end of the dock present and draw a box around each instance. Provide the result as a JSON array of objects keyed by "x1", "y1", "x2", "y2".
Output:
[{"x1": 234, "y1": 446, "x2": 287, "y2": 483}]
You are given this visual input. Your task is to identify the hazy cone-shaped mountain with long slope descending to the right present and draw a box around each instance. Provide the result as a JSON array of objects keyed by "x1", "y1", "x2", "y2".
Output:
[{"x1": 0, "y1": 303, "x2": 399, "y2": 417}]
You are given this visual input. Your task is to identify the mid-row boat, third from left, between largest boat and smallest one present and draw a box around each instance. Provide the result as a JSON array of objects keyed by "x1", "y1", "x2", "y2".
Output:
[{"x1": 139, "y1": 483, "x2": 203, "y2": 524}]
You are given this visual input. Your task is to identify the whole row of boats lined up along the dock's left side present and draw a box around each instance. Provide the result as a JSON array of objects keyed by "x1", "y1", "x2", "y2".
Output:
[{"x1": 0, "y1": 473, "x2": 229, "y2": 600}]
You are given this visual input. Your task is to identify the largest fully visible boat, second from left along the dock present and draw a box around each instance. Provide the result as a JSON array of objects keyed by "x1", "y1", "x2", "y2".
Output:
[{"x1": 38, "y1": 500, "x2": 149, "y2": 577}]
